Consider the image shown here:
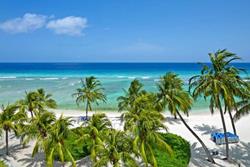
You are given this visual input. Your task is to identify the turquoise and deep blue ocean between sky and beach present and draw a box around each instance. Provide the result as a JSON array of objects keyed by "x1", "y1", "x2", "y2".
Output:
[{"x1": 0, "y1": 63, "x2": 250, "y2": 111}]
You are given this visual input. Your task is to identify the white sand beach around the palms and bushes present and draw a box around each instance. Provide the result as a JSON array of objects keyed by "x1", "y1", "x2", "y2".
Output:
[{"x1": 0, "y1": 110, "x2": 250, "y2": 167}]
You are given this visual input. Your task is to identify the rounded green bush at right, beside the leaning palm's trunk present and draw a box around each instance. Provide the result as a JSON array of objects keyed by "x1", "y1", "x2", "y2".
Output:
[{"x1": 154, "y1": 133, "x2": 191, "y2": 167}]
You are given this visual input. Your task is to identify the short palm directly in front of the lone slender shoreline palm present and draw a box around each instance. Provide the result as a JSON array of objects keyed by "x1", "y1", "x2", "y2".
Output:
[{"x1": 76, "y1": 113, "x2": 112, "y2": 162}]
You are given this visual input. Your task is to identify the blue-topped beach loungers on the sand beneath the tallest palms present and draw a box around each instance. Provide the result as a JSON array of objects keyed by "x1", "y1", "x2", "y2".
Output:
[{"x1": 211, "y1": 132, "x2": 239, "y2": 145}]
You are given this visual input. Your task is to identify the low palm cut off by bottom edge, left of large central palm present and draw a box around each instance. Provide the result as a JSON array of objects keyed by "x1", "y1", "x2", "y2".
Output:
[{"x1": 94, "y1": 130, "x2": 139, "y2": 167}]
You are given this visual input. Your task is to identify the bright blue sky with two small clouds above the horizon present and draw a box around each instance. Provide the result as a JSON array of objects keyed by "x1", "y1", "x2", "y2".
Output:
[{"x1": 0, "y1": 0, "x2": 250, "y2": 62}]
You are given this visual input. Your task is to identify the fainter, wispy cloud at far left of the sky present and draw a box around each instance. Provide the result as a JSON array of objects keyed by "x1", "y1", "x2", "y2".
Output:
[{"x1": 0, "y1": 13, "x2": 47, "y2": 33}]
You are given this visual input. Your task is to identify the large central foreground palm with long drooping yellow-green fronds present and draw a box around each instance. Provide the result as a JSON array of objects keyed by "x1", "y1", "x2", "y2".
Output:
[{"x1": 123, "y1": 94, "x2": 172, "y2": 167}]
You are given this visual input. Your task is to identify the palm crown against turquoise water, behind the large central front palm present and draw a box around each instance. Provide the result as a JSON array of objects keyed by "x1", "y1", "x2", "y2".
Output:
[{"x1": 117, "y1": 79, "x2": 145, "y2": 111}]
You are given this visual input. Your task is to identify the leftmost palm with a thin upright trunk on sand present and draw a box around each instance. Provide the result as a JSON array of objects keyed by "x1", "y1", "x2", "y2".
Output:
[{"x1": 0, "y1": 104, "x2": 25, "y2": 155}]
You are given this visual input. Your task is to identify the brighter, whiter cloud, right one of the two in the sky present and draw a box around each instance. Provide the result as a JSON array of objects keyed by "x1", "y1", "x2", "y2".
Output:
[{"x1": 46, "y1": 16, "x2": 87, "y2": 36}]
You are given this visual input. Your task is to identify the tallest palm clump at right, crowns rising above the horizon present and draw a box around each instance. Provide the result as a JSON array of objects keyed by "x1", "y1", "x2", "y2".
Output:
[{"x1": 189, "y1": 49, "x2": 249, "y2": 159}]
